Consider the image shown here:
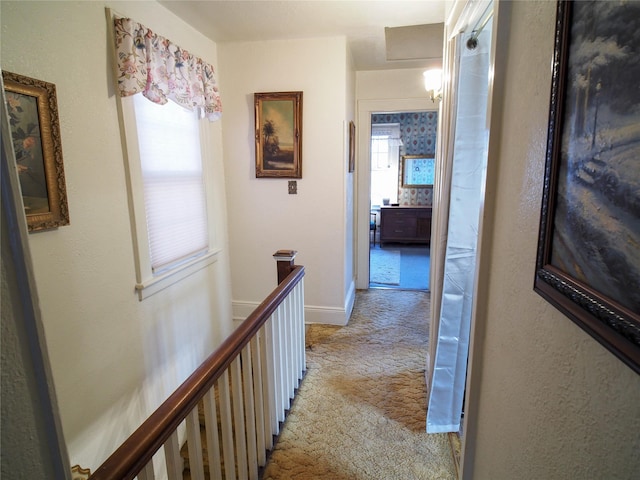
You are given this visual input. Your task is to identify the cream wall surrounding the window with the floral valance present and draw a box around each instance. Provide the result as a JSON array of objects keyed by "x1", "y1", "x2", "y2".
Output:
[{"x1": 0, "y1": 1, "x2": 231, "y2": 470}]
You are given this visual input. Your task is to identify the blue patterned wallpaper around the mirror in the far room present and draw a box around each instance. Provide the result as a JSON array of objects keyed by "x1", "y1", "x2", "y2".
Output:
[{"x1": 371, "y1": 112, "x2": 438, "y2": 206}]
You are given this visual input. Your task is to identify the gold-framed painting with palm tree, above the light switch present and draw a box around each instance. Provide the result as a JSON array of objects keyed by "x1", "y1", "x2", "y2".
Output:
[{"x1": 254, "y1": 92, "x2": 302, "y2": 178}]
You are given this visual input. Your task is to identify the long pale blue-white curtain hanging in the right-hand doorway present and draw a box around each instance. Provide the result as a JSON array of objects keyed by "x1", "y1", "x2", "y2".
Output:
[{"x1": 427, "y1": 20, "x2": 491, "y2": 433}]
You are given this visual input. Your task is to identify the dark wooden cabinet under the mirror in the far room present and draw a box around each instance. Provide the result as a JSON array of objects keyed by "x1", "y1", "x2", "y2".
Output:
[{"x1": 380, "y1": 207, "x2": 431, "y2": 244}]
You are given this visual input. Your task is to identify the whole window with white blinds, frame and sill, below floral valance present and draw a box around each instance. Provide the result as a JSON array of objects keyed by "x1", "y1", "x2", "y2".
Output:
[{"x1": 115, "y1": 94, "x2": 219, "y2": 300}]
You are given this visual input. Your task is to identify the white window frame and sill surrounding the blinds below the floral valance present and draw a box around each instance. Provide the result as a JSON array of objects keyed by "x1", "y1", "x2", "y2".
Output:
[{"x1": 118, "y1": 94, "x2": 221, "y2": 300}]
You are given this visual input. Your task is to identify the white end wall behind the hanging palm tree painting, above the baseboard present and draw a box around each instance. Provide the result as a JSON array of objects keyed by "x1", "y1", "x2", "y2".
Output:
[{"x1": 219, "y1": 37, "x2": 351, "y2": 324}]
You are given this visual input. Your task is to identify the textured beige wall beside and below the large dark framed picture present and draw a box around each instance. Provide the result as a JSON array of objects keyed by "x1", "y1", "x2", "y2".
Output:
[{"x1": 464, "y1": 1, "x2": 640, "y2": 480}]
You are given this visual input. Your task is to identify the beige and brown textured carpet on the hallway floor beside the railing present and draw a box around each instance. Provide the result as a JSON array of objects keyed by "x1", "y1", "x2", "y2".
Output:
[{"x1": 263, "y1": 289, "x2": 456, "y2": 480}]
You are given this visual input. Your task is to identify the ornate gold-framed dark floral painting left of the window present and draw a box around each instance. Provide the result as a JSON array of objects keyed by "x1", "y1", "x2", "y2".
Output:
[{"x1": 2, "y1": 71, "x2": 69, "y2": 232}]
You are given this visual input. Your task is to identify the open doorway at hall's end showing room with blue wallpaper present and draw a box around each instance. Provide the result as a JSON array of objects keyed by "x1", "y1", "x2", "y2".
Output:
[{"x1": 369, "y1": 110, "x2": 438, "y2": 291}]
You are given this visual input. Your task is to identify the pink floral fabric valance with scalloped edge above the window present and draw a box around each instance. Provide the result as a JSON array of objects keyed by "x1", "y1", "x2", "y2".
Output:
[{"x1": 114, "y1": 17, "x2": 222, "y2": 121}]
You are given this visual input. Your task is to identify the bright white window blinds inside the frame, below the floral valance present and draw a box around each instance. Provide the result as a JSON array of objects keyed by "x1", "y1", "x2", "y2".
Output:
[{"x1": 133, "y1": 95, "x2": 209, "y2": 274}]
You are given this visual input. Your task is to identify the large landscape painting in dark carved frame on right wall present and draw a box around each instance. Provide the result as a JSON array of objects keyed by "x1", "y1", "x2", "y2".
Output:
[{"x1": 534, "y1": 1, "x2": 640, "y2": 373}]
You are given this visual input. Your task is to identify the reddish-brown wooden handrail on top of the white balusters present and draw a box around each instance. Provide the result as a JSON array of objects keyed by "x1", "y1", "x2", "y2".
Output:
[{"x1": 89, "y1": 265, "x2": 304, "y2": 480}]
